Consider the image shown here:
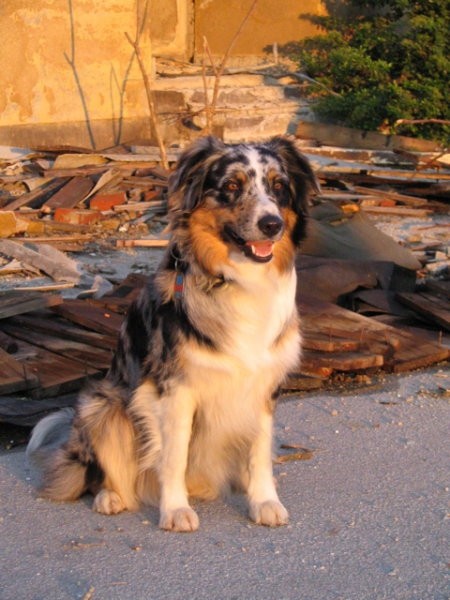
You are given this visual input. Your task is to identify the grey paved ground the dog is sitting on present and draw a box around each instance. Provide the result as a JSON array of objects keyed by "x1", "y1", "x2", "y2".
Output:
[{"x1": 0, "y1": 369, "x2": 450, "y2": 600}]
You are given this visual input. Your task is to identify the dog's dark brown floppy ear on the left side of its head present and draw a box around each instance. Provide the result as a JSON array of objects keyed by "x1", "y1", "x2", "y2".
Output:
[{"x1": 169, "y1": 136, "x2": 224, "y2": 210}]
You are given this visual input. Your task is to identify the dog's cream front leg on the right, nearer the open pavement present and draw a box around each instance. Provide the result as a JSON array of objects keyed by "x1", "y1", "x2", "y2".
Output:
[{"x1": 247, "y1": 408, "x2": 289, "y2": 527}]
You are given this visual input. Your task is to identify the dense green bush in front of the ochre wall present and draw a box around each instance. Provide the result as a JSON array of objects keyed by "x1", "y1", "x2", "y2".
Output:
[{"x1": 282, "y1": 0, "x2": 450, "y2": 144}]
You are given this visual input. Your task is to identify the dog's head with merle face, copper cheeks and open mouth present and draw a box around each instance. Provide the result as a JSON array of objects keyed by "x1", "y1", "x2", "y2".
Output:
[{"x1": 169, "y1": 136, "x2": 317, "y2": 274}]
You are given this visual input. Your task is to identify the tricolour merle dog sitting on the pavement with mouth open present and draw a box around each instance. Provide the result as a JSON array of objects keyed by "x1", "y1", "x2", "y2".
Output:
[{"x1": 27, "y1": 136, "x2": 317, "y2": 532}]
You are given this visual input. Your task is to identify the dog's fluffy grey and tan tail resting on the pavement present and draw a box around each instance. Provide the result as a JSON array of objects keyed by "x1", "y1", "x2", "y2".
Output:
[{"x1": 26, "y1": 408, "x2": 87, "y2": 500}]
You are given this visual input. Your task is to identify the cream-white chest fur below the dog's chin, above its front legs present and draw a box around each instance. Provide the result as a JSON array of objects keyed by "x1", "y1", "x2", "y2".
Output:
[{"x1": 181, "y1": 261, "x2": 300, "y2": 380}]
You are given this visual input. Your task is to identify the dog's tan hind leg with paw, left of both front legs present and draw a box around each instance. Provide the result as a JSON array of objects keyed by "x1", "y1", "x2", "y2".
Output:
[{"x1": 79, "y1": 381, "x2": 138, "y2": 514}]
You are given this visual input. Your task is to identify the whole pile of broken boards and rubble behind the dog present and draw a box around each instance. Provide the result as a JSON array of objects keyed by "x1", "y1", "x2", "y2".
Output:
[{"x1": 0, "y1": 125, "x2": 450, "y2": 425}]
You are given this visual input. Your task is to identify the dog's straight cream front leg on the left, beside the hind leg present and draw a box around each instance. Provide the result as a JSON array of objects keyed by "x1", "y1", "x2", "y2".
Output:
[{"x1": 159, "y1": 388, "x2": 199, "y2": 531}]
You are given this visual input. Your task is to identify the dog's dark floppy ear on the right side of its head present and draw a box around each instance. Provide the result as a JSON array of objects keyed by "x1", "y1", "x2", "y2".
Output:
[{"x1": 268, "y1": 135, "x2": 320, "y2": 215}]
